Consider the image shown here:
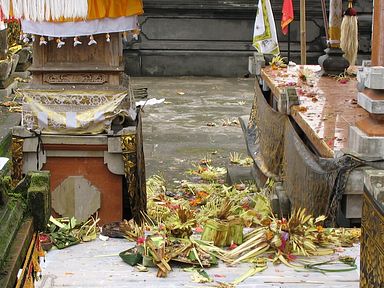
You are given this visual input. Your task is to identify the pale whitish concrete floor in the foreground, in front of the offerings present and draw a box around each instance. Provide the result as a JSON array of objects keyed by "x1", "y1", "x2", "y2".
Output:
[{"x1": 36, "y1": 239, "x2": 359, "y2": 288}]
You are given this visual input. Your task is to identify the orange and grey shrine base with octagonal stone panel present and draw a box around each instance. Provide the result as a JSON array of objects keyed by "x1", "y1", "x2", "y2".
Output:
[{"x1": 13, "y1": 127, "x2": 135, "y2": 225}]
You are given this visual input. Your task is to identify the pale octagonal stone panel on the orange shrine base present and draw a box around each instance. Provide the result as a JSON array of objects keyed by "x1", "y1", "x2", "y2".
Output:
[{"x1": 52, "y1": 176, "x2": 100, "y2": 222}]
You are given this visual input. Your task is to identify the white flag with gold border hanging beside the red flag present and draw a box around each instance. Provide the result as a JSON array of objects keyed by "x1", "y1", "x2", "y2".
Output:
[{"x1": 253, "y1": 0, "x2": 280, "y2": 55}]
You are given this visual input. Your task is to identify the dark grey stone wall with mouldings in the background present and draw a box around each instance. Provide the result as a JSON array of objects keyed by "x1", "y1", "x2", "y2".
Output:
[{"x1": 124, "y1": 0, "x2": 372, "y2": 77}]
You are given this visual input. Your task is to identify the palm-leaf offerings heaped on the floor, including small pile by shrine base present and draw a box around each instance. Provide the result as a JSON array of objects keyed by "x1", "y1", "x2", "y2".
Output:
[{"x1": 42, "y1": 161, "x2": 360, "y2": 287}]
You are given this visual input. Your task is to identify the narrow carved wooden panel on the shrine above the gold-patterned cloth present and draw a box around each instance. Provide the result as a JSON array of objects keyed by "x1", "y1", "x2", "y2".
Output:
[{"x1": 43, "y1": 73, "x2": 108, "y2": 84}]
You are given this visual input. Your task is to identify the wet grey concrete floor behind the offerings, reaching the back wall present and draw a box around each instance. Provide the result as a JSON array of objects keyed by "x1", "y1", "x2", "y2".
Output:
[{"x1": 133, "y1": 77, "x2": 254, "y2": 182}]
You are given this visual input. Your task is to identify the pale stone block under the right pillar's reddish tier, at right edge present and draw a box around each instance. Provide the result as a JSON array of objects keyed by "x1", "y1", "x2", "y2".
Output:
[{"x1": 348, "y1": 126, "x2": 384, "y2": 158}]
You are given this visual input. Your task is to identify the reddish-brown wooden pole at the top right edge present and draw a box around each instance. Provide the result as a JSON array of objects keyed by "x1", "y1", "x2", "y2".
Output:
[{"x1": 371, "y1": 0, "x2": 384, "y2": 66}]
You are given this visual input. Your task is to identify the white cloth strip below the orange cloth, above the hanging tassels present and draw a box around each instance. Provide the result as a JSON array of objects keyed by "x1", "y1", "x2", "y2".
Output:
[{"x1": 21, "y1": 15, "x2": 138, "y2": 37}]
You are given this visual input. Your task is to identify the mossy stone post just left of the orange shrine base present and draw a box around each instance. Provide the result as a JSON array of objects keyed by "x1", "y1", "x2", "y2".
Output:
[{"x1": 28, "y1": 171, "x2": 51, "y2": 231}]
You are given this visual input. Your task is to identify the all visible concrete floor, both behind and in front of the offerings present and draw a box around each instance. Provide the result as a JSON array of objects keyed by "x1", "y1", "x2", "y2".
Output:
[{"x1": 33, "y1": 77, "x2": 359, "y2": 288}]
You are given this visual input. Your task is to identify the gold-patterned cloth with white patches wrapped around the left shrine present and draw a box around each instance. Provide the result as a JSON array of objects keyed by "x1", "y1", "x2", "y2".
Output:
[{"x1": 17, "y1": 90, "x2": 132, "y2": 134}]
